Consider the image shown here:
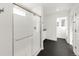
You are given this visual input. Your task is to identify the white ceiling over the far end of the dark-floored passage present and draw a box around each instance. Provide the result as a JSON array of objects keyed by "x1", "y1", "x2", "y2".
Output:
[{"x1": 43, "y1": 3, "x2": 73, "y2": 15}]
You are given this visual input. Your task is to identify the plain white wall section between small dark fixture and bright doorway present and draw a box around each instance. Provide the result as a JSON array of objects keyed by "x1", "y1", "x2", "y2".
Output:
[{"x1": 44, "y1": 15, "x2": 56, "y2": 40}]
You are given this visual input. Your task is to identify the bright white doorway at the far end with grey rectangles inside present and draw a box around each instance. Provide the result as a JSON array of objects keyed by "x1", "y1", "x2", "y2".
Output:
[{"x1": 57, "y1": 17, "x2": 68, "y2": 39}]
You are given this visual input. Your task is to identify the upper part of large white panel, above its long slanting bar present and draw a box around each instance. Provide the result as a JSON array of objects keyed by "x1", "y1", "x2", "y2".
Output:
[{"x1": 14, "y1": 7, "x2": 33, "y2": 39}]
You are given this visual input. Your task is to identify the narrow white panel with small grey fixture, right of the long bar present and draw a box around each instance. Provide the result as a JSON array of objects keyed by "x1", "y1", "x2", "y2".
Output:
[{"x1": 33, "y1": 15, "x2": 40, "y2": 55}]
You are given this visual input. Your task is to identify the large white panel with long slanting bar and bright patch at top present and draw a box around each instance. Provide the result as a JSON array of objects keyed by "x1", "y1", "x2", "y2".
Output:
[{"x1": 13, "y1": 6, "x2": 33, "y2": 56}]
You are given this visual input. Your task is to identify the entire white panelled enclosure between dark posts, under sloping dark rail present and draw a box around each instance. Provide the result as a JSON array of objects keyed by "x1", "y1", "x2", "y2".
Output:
[{"x1": 13, "y1": 6, "x2": 40, "y2": 56}]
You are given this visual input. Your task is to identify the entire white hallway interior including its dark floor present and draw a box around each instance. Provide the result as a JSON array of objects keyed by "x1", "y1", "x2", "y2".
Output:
[{"x1": 0, "y1": 3, "x2": 79, "y2": 56}]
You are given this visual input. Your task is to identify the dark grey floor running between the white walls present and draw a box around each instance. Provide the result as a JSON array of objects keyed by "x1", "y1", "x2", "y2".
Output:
[{"x1": 38, "y1": 38, "x2": 75, "y2": 56}]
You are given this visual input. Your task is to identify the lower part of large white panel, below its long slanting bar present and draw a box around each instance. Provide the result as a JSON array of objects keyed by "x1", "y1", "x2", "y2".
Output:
[{"x1": 14, "y1": 36, "x2": 32, "y2": 56}]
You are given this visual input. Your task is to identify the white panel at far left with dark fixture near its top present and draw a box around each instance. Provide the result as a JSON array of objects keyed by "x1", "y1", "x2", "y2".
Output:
[{"x1": 0, "y1": 3, "x2": 13, "y2": 56}]
